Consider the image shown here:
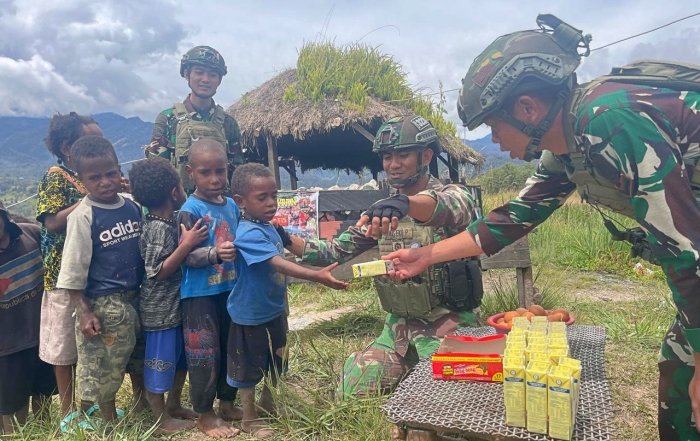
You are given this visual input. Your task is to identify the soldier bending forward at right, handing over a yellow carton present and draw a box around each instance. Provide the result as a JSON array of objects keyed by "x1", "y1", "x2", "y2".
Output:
[{"x1": 385, "y1": 16, "x2": 700, "y2": 441}]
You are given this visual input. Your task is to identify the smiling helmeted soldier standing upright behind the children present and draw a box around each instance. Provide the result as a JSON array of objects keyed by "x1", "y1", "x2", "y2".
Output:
[{"x1": 146, "y1": 46, "x2": 243, "y2": 194}]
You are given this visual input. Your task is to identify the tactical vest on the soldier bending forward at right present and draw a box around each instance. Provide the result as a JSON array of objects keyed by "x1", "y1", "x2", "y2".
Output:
[{"x1": 560, "y1": 60, "x2": 700, "y2": 219}]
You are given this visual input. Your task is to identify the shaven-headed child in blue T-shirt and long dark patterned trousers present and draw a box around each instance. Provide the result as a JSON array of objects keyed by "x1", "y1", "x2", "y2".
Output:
[{"x1": 177, "y1": 138, "x2": 242, "y2": 438}]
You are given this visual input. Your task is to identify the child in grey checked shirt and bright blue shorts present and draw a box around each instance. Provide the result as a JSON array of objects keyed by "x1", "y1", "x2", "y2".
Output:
[{"x1": 129, "y1": 157, "x2": 207, "y2": 434}]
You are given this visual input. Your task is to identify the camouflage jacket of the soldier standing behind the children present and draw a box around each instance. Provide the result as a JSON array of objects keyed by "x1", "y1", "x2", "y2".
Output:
[{"x1": 149, "y1": 95, "x2": 244, "y2": 165}]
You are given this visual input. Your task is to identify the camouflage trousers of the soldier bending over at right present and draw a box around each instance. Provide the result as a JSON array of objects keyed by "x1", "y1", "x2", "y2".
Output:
[{"x1": 659, "y1": 317, "x2": 700, "y2": 441}]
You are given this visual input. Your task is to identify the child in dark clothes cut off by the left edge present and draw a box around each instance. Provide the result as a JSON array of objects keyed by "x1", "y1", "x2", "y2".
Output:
[{"x1": 0, "y1": 202, "x2": 56, "y2": 435}]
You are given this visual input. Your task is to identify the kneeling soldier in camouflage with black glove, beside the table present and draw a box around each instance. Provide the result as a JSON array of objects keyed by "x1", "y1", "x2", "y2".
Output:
[{"x1": 303, "y1": 115, "x2": 477, "y2": 398}]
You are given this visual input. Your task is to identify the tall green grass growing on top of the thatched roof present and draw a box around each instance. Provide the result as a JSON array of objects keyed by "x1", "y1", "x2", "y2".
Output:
[{"x1": 296, "y1": 41, "x2": 457, "y2": 135}]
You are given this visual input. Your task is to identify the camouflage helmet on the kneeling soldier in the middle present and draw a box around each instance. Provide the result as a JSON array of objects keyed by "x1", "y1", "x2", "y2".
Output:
[{"x1": 372, "y1": 115, "x2": 440, "y2": 154}]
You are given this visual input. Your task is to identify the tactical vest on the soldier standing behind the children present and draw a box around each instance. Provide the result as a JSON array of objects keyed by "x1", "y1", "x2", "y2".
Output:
[{"x1": 170, "y1": 103, "x2": 228, "y2": 193}]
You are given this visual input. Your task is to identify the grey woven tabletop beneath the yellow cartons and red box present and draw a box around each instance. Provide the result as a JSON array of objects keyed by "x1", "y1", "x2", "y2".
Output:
[{"x1": 381, "y1": 325, "x2": 614, "y2": 441}]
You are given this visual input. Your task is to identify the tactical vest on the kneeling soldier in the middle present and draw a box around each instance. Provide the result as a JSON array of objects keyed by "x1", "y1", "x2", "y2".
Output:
[{"x1": 374, "y1": 216, "x2": 442, "y2": 319}]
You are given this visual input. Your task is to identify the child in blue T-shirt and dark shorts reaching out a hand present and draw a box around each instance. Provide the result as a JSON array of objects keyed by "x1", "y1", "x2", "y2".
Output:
[{"x1": 228, "y1": 163, "x2": 348, "y2": 438}]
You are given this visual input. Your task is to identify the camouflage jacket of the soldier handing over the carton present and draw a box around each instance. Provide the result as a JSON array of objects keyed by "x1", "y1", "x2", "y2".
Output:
[{"x1": 468, "y1": 83, "x2": 700, "y2": 352}]
